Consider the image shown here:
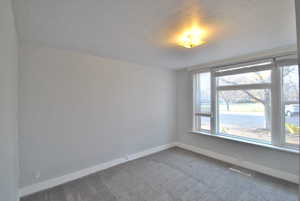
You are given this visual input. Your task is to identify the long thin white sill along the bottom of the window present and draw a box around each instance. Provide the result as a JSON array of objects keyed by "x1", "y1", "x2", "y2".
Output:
[{"x1": 189, "y1": 131, "x2": 300, "y2": 154}]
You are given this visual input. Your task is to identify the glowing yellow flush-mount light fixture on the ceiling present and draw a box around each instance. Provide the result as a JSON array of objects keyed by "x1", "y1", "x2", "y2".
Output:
[{"x1": 178, "y1": 27, "x2": 205, "y2": 48}]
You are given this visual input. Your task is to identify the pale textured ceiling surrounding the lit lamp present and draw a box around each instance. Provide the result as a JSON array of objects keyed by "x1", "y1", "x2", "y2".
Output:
[{"x1": 14, "y1": 0, "x2": 296, "y2": 69}]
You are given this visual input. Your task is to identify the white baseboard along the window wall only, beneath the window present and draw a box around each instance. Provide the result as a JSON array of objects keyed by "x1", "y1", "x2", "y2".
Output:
[{"x1": 175, "y1": 143, "x2": 299, "y2": 184}]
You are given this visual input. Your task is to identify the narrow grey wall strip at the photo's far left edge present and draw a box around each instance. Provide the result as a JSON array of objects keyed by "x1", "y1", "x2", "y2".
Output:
[{"x1": 0, "y1": 0, "x2": 18, "y2": 201}]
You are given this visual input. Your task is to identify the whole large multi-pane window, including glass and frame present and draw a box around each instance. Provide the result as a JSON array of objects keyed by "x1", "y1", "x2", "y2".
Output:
[{"x1": 193, "y1": 56, "x2": 300, "y2": 148}]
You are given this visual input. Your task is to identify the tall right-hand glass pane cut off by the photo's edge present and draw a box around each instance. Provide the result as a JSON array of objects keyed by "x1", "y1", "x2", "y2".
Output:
[{"x1": 282, "y1": 65, "x2": 300, "y2": 145}]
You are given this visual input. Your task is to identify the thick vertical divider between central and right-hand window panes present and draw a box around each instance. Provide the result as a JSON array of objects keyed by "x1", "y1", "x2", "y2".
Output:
[{"x1": 271, "y1": 58, "x2": 284, "y2": 146}]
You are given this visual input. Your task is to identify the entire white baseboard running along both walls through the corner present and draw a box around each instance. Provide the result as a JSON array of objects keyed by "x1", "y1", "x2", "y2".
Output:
[{"x1": 19, "y1": 142, "x2": 299, "y2": 197}]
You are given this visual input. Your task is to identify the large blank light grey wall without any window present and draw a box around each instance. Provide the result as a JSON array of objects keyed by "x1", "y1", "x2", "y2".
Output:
[{"x1": 19, "y1": 44, "x2": 176, "y2": 187}]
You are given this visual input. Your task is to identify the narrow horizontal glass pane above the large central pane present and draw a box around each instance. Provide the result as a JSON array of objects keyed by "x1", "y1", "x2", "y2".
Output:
[{"x1": 218, "y1": 70, "x2": 271, "y2": 86}]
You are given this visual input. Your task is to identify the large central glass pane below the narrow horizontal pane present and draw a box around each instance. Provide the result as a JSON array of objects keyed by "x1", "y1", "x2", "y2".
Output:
[{"x1": 217, "y1": 89, "x2": 271, "y2": 142}]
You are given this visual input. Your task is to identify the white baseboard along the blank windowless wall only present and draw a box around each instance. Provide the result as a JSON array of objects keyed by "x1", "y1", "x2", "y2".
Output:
[{"x1": 19, "y1": 143, "x2": 177, "y2": 197}]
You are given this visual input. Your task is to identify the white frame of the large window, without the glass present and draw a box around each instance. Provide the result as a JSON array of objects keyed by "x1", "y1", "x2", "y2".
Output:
[{"x1": 193, "y1": 54, "x2": 299, "y2": 151}]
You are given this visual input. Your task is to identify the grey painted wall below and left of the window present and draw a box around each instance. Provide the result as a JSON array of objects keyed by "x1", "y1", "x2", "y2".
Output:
[{"x1": 176, "y1": 70, "x2": 299, "y2": 175}]
